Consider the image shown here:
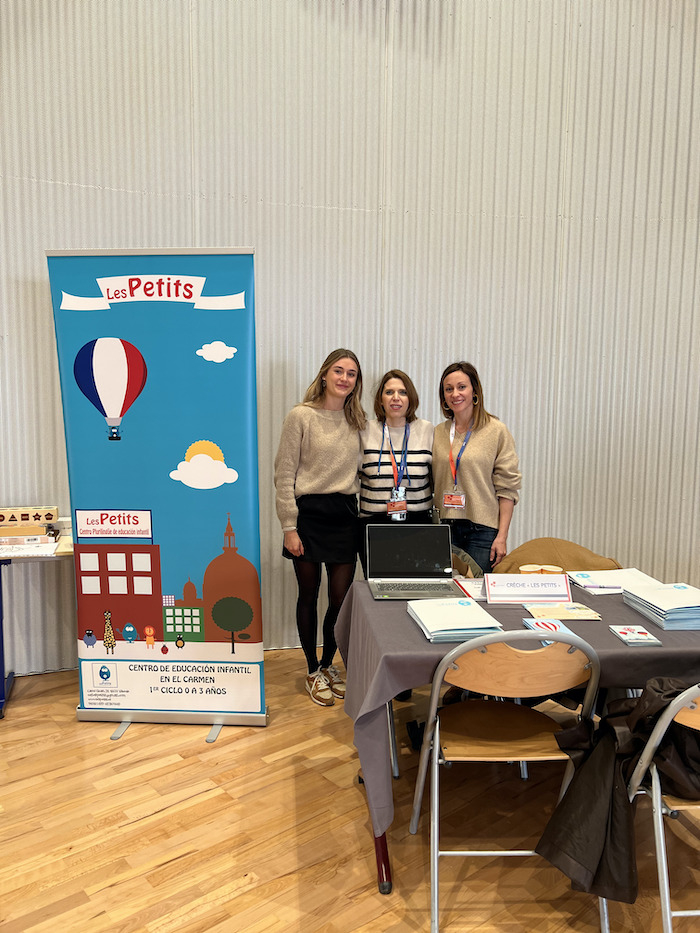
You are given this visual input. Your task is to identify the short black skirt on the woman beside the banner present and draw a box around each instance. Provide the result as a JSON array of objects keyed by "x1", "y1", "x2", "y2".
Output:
[{"x1": 282, "y1": 492, "x2": 359, "y2": 564}]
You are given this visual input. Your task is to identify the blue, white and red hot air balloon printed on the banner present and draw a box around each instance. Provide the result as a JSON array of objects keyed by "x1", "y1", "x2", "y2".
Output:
[{"x1": 73, "y1": 337, "x2": 146, "y2": 441}]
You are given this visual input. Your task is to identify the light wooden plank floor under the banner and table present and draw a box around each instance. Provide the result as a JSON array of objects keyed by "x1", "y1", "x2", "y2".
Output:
[{"x1": 0, "y1": 651, "x2": 700, "y2": 933}]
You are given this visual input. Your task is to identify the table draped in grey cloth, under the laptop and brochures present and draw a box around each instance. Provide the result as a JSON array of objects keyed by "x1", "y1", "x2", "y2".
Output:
[{"x1": 335, "y1": 581, "x2": 700, "y2": 893}]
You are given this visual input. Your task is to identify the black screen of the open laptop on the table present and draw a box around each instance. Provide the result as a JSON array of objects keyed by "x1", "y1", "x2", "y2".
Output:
[{"x1": 367, "y1": 522, "x2": 452, "y2": 580}]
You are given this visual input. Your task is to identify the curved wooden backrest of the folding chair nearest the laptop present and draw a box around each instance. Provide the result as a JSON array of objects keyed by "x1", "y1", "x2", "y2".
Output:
[{"x1": 433, "y1": 631, "x2": 600, "y2": 715}]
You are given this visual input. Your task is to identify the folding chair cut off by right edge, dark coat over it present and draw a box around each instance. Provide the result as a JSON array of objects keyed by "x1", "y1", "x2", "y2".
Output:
[{"x1": 598, "y1": 683, "x2": 700, "y2": 933}]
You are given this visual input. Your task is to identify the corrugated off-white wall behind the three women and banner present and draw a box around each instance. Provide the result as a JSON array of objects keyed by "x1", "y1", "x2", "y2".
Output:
[{"x1": 0, "y1": 0, "x2": 700, "y2": 672}]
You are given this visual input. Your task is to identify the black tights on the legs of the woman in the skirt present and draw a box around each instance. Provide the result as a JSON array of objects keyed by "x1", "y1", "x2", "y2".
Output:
[{"x1": 293, "y1": 558, "x2": 355, "y2": 674}]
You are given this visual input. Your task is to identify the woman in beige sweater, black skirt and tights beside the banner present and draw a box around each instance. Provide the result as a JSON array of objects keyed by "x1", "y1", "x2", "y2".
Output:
[{"x1": 275, "y1": 348, "x2": 365, "y2": 706}]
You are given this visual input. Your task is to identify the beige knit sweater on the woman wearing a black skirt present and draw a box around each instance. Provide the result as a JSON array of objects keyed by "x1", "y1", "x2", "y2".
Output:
[{"x1": 275, "y1": 405, "x2": 360, "y2": 531}]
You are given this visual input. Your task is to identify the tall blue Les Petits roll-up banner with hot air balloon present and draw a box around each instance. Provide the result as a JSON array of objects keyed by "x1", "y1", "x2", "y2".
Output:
[{"x1": 47, "y1": 250, "x2": 266, "y2": 725}]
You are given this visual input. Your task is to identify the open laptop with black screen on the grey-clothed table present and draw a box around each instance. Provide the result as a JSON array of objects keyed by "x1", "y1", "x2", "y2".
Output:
[{"x1": 366, "y1": 522, "x2": 464, "y2": 599}]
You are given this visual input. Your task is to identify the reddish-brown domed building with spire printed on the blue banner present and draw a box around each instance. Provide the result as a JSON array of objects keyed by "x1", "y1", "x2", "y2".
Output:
[{"x1": 202, "y1": 514, "x2": 262, "y2": 643}]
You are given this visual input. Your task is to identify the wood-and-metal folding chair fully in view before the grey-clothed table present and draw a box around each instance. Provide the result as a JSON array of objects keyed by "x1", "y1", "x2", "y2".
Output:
[{"x1": 410, "y1": 631, "x2": 600, "y2": 933}]
